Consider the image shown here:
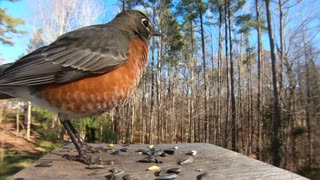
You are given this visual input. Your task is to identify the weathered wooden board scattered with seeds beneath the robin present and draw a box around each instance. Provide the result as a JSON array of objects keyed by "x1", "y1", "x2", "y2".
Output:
[{"x1": 10, "y1": 143, "x2": 306, "y2": 180}]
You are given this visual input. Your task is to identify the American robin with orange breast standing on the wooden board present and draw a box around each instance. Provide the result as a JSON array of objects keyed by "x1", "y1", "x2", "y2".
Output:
[{"x1": 0, "y1": 10, "x2": 161, "y2": 164}]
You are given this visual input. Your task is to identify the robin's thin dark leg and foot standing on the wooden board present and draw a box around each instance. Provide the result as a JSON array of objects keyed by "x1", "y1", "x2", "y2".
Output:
[{"x1": 60, "y1": 120, "x2": 99, "y2": 164}]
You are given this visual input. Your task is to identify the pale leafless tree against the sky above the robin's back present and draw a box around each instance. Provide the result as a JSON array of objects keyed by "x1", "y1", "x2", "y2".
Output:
[{"x1": 31, "y1": 0, "x2": 103, "y2": 44}]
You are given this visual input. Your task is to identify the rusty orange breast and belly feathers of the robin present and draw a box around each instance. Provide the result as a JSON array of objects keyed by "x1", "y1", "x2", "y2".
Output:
[{"x1": 39, "y1": 38, "x2": 148, "y2": 116}]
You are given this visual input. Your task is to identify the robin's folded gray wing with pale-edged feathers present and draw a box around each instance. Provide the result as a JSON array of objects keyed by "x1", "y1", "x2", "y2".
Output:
[{"x1": 0, "y1": 25, "x2": 129, "y2": 86}]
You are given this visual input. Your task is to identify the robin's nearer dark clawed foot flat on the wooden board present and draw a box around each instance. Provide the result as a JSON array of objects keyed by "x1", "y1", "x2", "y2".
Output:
[{"x1": 63, "y1": 154, "x2": 109, "y2": 165}]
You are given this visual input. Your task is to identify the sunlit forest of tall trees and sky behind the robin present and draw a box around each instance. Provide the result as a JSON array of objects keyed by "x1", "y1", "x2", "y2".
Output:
[{"x1": 0, "y1": 0, "x2": 320, "y2": 178}]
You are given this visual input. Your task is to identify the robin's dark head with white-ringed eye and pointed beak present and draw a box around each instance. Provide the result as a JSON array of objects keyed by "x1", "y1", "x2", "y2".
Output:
[{"x1": 111, "y1": 10, "x2": 161, "y2": 42}]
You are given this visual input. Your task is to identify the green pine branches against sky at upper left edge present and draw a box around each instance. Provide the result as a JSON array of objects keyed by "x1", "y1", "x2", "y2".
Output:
[{"x1": 0, "y1": 8, "x2": 26, "y2": 46}]
